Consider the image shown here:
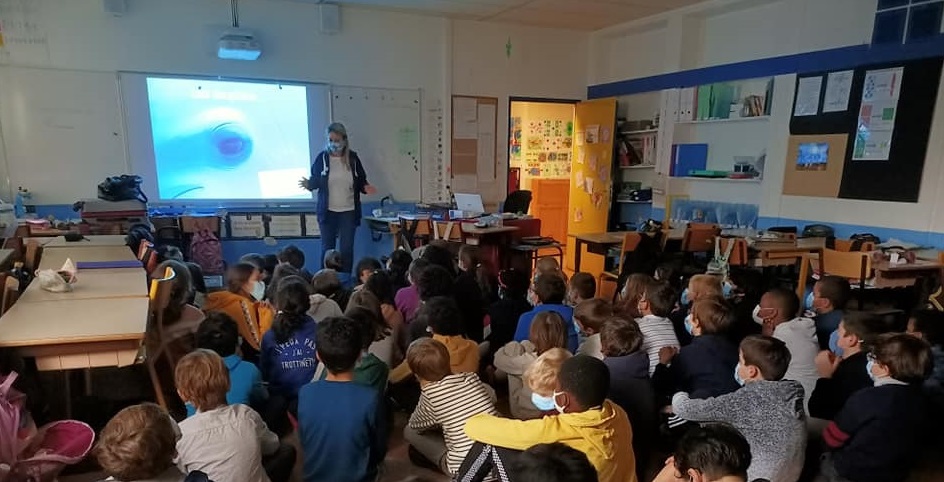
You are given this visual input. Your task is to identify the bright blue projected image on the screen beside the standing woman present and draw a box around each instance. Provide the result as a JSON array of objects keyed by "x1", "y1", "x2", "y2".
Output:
[{"x1": 147, "y1": 77, "x2": 311, "y2": 200}]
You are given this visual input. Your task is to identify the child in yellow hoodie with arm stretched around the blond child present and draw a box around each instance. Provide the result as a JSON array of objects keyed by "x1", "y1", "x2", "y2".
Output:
[{"x1": 465, "y1": 355, "x2": 636, "y2": 482}]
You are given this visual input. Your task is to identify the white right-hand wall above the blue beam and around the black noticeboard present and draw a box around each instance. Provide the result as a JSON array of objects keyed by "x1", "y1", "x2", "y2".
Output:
[{"x1": 589, "y1": 0, "x2": 944, "y2": 232}]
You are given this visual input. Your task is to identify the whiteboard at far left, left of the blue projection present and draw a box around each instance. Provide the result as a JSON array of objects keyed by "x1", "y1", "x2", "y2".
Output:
[{"x1": 0, "y1": 67, "x2": 129, "y2": 204}]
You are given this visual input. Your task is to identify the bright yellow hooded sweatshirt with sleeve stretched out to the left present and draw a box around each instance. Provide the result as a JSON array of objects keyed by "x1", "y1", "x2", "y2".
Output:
[{"x1": 465, "y1": 400, "x2": 636, "y2": 482}]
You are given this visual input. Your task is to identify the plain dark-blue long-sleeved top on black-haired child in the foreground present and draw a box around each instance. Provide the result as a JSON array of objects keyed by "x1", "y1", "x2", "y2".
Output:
[{"x1": 298, "y1": 381, "x2": 386, "y2": 482}]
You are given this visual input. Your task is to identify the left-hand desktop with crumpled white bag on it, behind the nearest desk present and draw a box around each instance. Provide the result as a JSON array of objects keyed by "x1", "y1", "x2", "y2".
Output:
[{"x1": 17, "y1": 268, "x2": 148, "y2": 309}]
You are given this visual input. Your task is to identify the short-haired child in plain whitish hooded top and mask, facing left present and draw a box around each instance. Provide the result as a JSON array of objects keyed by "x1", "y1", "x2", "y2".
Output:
[{"x1": 754, "y1": 288, "x2": 819, "y2": 407}]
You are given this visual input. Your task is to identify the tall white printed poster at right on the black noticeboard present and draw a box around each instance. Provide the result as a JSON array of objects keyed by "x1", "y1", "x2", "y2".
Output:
[{"x1": 852, "y1": 67, "x2": 904, "y2": 161}]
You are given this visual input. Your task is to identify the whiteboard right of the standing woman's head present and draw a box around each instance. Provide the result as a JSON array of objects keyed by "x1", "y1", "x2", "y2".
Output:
[{"x1": 331, "y1": 86, "x2": 423, "y2": 201}]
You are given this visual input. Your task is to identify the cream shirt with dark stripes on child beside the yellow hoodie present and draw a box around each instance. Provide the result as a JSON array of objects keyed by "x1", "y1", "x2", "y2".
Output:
[{"x1": 410, "y1": 373, "x2": 498, "y2": 474}]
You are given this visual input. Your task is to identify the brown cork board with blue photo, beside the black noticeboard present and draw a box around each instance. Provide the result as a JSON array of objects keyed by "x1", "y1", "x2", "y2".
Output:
[{"x1": 783, "y1": 134, "x2": 849, "y2": 198}]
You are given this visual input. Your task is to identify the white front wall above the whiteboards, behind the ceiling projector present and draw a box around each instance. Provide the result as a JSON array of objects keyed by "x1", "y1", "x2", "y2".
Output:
[{"x1": 0, "y1": 0, "x2": 588, "y2": 201}]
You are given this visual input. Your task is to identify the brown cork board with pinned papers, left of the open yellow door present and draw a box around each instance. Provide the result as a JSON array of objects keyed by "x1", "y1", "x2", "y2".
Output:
[{"x1": 451, "y1": 95, "x2": 498, "y2": 184}]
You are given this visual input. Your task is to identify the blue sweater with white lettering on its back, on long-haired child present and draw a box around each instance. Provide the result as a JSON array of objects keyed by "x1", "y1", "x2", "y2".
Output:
[{"x1": 259, "y1": 315, "x2": 318, "y2": 399}]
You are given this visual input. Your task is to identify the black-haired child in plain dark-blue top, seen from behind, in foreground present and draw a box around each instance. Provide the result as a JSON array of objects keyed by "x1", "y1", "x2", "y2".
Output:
[{"x1": 298, "y1": 317, "x2": 387, "y2": 482}]
